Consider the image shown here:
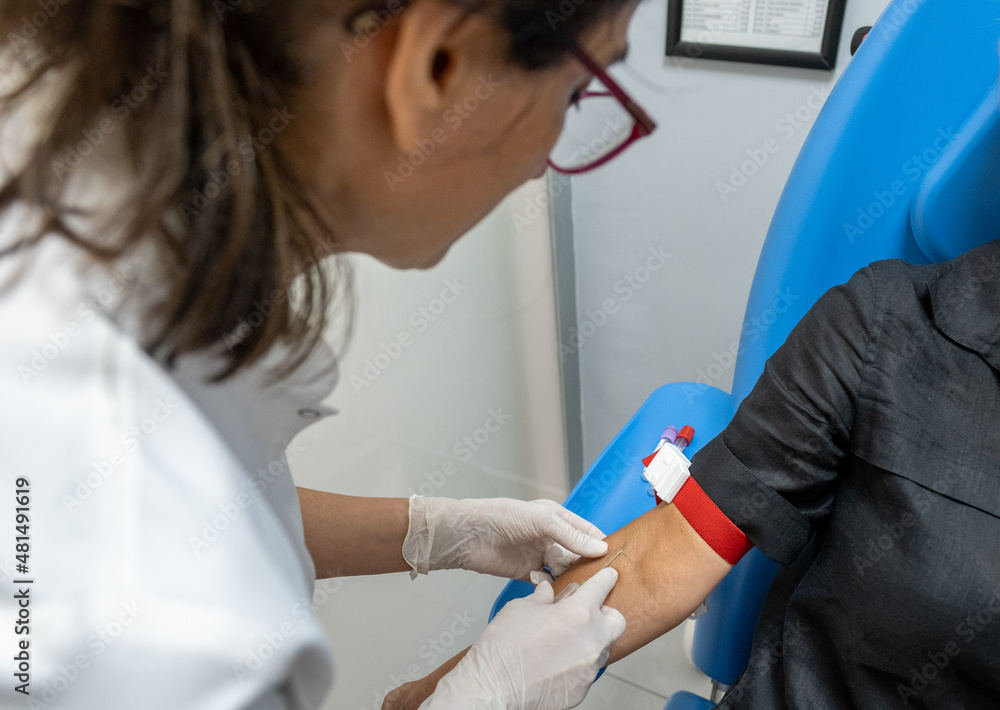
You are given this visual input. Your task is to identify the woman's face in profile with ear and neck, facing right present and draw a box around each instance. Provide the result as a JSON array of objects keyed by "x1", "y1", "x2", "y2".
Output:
[{"x1": 279, "y1": 0, "x2": 638, "y2": 268}]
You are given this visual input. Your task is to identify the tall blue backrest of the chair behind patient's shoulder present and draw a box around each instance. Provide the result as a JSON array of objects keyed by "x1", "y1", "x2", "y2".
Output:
[{"x1": 733, "y1": 0, "x2": 1000, "y2": 404}]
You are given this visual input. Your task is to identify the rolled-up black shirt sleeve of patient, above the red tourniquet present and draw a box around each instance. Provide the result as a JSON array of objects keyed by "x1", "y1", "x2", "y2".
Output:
[{"x1": 691, "y1": 267, "x2": 878, "y2": 564}]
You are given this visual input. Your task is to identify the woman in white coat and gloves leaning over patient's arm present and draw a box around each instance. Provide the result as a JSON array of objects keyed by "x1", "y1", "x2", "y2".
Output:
[{"x1": 0, "y1": 0, "x2": 652, "y2": 710}]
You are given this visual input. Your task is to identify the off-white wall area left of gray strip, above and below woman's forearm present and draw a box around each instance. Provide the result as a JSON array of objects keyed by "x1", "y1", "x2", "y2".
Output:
[{"x1": 289, "y1": 181, "x2": 568, "y2": 710}]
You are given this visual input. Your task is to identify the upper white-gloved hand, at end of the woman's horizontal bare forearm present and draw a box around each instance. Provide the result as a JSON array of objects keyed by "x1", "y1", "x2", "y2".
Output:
[{"x1": 403, "y1": 495, "x2": 608, "y2": 581}]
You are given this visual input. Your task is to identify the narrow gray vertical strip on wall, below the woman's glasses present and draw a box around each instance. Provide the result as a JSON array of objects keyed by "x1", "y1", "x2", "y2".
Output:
[{"x1": 547, "y1": 170, "x2": 583, "y2": 486}]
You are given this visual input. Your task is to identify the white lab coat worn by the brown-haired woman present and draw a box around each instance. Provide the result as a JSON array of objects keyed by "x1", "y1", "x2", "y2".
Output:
[{"x1": 0, "y1": 196, "x2": 337, "y2": 710}]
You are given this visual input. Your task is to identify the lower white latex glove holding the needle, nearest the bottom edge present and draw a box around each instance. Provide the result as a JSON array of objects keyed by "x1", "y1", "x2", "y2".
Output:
[{"x1": 419, "y1": 567, "x2": 625, "y2": 710}]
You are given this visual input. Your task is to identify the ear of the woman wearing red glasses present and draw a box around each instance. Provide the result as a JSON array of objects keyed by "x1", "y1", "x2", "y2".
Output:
[{"x1": 385, "y1": 0, "x2": 510, "y2": 154}]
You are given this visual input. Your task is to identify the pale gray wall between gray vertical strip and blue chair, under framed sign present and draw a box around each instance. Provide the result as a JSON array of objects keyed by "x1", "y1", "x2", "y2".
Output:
[{"x1": 573, "y1": 0, "x2": 888, "y2": 466}]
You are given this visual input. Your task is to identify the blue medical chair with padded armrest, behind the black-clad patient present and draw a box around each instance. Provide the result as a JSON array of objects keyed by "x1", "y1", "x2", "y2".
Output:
[{"x1": 491, "y1": 0, "x2": 1000, "y2": 710}]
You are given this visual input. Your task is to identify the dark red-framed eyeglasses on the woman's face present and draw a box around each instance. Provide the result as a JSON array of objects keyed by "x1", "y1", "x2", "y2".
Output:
[{"x1": 549, "y1": 47, "x2": 656, "y2": 175}]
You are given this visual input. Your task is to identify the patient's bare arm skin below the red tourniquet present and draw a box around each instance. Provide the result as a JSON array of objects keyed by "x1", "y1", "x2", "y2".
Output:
[{"x1": 382, "y1": 503, "x2": 732, "y2": 710}]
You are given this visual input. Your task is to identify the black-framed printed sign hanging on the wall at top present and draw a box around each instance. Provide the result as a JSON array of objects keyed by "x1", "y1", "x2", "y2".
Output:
[{"x1": 667, "y1": 0, "x2": 847, "y2": 69}]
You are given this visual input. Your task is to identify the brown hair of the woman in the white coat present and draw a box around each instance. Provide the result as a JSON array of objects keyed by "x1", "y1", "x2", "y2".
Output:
[{"x1": 0, "y1": 0, "x2": 624, "y2": 379}]
